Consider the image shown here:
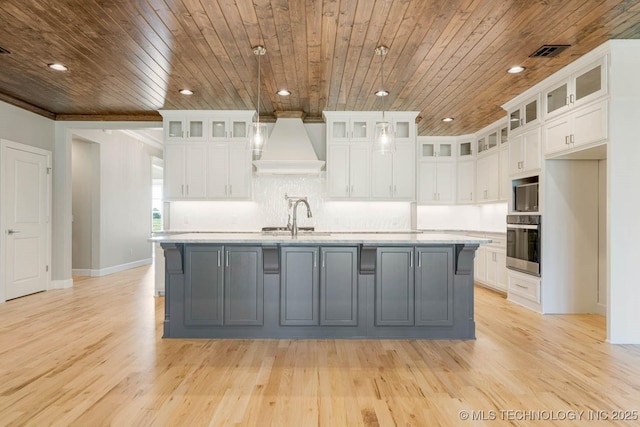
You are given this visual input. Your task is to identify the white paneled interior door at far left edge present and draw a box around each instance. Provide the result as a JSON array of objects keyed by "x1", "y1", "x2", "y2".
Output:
[{"x1": 2, "y1": 144, "x2": 50, "y2": 299}]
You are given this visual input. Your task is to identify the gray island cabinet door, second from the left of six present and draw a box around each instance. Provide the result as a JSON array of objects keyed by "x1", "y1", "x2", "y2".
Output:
[{"x1": 224, "y1": 246, "x2": 264, "y2": 326}]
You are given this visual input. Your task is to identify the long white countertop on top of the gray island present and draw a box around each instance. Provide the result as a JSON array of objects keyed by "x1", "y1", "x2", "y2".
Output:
[{"x1": 149, "y1": 232, "x2": 491, "y2": 246}]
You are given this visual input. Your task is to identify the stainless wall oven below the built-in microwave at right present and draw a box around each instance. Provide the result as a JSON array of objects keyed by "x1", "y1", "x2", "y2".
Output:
[{"x1": 507, "y1": 214, "x2": 542, "y2": 276}]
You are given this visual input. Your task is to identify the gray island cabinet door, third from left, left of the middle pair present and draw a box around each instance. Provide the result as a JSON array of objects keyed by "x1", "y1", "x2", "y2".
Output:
[{"x1": 280, "y1": 246, "x2": 319, "y2": 326}]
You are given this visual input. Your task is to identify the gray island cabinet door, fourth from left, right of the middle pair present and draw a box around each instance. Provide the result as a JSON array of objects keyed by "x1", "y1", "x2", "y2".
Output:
[{"x1": 320, "y1": 247, "x2": 358, "y2": 326}]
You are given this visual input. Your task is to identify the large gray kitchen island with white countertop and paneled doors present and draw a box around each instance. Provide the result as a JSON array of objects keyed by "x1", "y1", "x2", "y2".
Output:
[{"x1": 152, "y1": 233, "x2": 489, "y2": 339}]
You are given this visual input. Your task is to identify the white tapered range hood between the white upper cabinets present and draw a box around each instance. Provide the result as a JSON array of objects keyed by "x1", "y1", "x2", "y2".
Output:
[{"x1": 253, "y1": 111, "x2": 324, "y2": 175}]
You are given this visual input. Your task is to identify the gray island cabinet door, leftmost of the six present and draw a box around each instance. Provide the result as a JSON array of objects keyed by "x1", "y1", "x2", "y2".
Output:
[{"x1": 184, "y1": 245, "x2": 224, "y2": 326}]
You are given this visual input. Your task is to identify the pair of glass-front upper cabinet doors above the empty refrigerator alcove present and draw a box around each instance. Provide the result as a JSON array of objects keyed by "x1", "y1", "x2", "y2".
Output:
[{"x1": 543, "y1": 56, "x2": 607, "y2": 118}]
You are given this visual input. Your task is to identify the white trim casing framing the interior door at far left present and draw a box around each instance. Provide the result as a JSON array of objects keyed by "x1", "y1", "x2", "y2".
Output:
[{"x1": 0, "y1": 138, "x2": 53, "y2": 303}]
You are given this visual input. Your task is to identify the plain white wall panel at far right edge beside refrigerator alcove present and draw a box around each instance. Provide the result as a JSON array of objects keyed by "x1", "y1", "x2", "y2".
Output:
[{"x1": 607, "y1": 40, "x2": 640, "y2": 344}]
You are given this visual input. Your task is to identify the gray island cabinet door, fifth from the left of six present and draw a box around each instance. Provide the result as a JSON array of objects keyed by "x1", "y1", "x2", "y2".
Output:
[{"x1": 375, "y1": 247, "x2": 414, "y2": 326}]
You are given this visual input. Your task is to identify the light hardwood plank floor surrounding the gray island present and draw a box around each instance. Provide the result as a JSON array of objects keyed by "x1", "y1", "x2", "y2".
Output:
[{"x1": 0, "y1": 267, "x2": 640, "y2": 426}]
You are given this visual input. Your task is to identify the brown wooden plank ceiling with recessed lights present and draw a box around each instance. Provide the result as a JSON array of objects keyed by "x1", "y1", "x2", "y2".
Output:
[{"x1": 0, "y1": 0, "x2": 640, "y2": 135}]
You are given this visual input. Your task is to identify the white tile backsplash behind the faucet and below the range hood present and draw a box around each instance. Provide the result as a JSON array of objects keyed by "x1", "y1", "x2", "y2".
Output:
[{"x1": 169, "y1": 174, "x2": 412, "y2": 231}]
